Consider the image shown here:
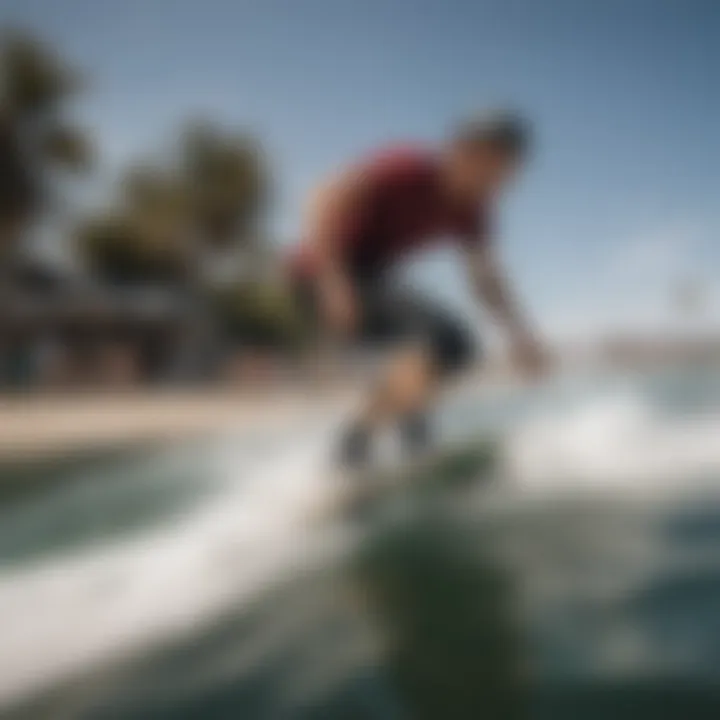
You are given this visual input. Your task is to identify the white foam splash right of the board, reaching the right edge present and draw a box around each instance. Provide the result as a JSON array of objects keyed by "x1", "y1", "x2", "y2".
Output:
[{"x1": 504, "y1": 387, "x2": 720, "y2": 493}]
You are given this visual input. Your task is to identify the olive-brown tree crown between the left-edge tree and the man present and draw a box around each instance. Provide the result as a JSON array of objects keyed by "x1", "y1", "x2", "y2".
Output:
[{"x1": 78, "y1": 123, "x2": 267, "y2": 282}]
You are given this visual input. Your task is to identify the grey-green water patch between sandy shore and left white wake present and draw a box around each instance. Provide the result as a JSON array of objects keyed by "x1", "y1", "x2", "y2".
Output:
[{"x1": 0, "y1": 441, "x2": 218, "y2": 570}]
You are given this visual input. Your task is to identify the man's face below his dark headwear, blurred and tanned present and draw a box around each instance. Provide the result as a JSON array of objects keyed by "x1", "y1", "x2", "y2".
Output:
[{"x1": 451, "y1": 144, "x2": 520, "y2": 199}]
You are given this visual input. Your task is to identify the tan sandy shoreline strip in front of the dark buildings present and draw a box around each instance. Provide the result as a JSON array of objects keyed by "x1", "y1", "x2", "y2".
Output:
[{"x1": 0, "y1": 387, "x2": 349, "y2": 464}]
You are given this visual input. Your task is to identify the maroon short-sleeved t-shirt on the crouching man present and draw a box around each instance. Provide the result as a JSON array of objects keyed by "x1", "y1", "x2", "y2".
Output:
[{"x1": 291, "y1": 147, "x2": 488, "y2": 278}]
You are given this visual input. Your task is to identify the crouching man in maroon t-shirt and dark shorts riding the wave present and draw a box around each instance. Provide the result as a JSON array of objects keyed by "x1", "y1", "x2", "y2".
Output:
[{"x1": 291, "y1": 112, "x2": 544, "y2": 467}]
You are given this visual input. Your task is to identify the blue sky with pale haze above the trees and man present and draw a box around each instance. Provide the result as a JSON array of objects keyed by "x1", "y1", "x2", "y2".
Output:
[{"x1": 0, "y1": 0, "x2": 720, "y2": 337}]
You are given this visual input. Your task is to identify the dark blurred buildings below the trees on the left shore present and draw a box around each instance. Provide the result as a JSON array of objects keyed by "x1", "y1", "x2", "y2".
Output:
[{"x1": 0, "y1": 261, "x2": 208, "y2": 389}]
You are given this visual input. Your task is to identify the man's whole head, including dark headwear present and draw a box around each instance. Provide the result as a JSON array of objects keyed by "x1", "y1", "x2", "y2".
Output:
[{"x1": 448, "y1": 112, "x2": 530, "y2": 199}]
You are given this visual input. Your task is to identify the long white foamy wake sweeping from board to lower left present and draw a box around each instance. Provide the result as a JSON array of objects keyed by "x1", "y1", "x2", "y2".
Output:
[{"x1": 0, "y1": 410, "x2": 352, "y2": 707}]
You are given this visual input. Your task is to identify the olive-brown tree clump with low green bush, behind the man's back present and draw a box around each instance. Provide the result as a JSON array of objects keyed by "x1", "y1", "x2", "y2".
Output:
[{"x1": 77, "y1": 118, "x2": 306, "y2": 376}]
